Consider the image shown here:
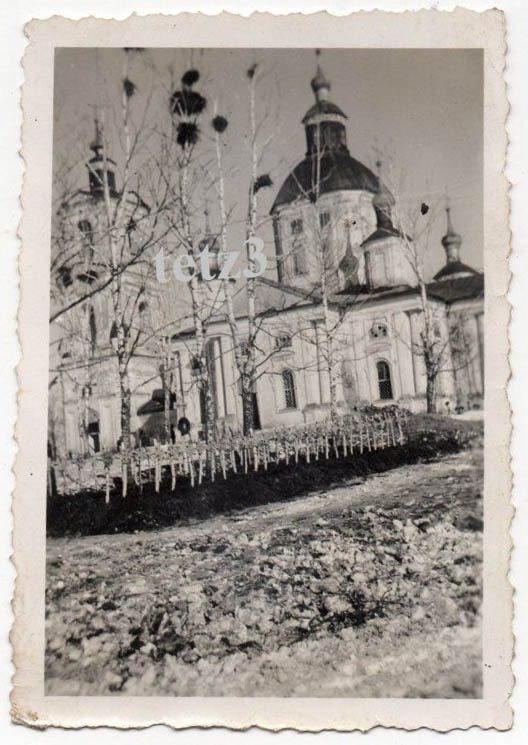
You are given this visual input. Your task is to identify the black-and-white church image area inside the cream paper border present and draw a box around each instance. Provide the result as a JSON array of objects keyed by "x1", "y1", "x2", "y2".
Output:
[{"x1": 45, "y1": 48, "x2": 485, "y2": 698}]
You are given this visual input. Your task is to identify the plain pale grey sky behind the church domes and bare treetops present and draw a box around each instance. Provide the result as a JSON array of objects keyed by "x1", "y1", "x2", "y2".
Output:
[{"x1": 54, "y1": 48, "x2": 483, "y2": 274}]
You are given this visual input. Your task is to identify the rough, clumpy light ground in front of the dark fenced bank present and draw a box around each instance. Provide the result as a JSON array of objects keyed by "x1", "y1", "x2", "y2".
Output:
[{"x1": 46, "y1": 444, "x2": 482, "y2": 698}]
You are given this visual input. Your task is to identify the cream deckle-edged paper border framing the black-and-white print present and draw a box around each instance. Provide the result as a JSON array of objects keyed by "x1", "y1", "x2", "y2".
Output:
[{"x1": 11, "y1": 8, "x2": 513, "y2": 731}]
